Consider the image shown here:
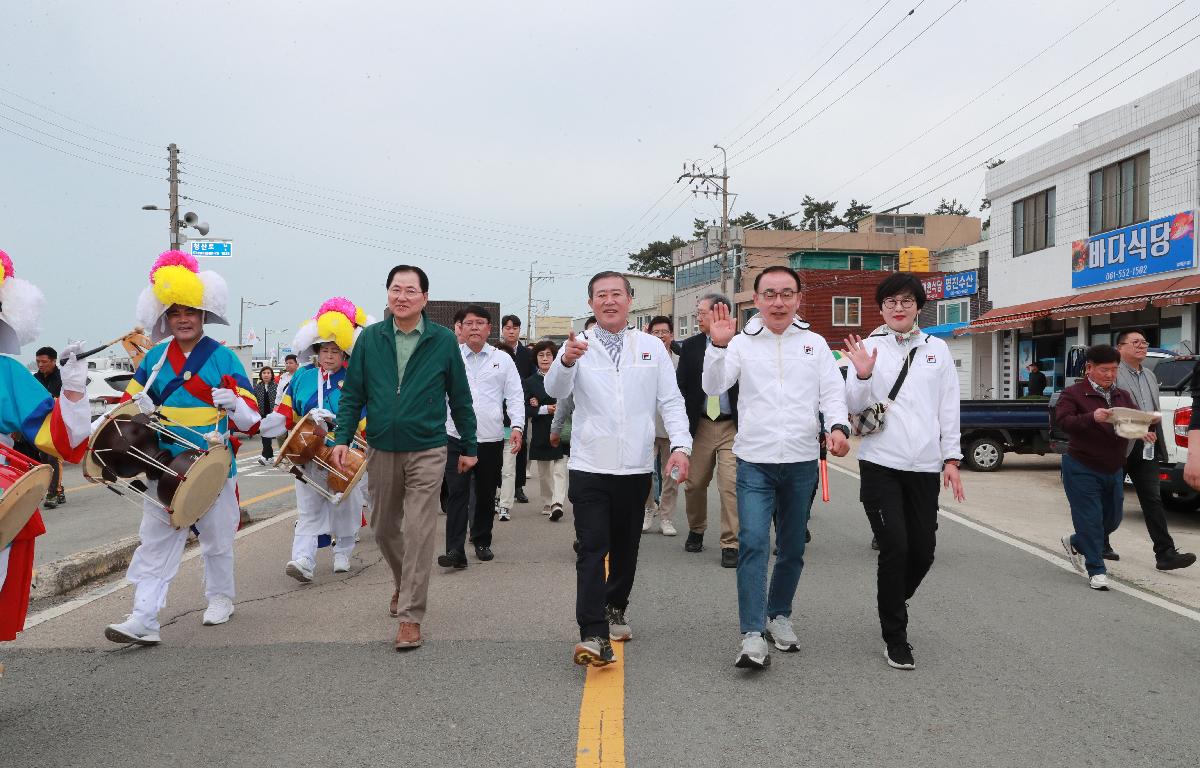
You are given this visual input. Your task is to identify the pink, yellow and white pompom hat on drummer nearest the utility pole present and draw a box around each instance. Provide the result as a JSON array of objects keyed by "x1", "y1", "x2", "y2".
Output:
[{"x1": 138, "y1": 251, "x2": 229, "y2": 344}]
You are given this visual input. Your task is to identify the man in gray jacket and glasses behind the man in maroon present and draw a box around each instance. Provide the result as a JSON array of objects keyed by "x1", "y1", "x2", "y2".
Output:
[{"x1": 1104, "y1": 331, "x2": 1196, "y2": 571}]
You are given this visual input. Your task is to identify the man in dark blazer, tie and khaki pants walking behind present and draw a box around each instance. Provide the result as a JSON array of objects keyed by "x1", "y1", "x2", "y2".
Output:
[{"x1": 676, "y1": 293, "x2": 738, "y2": 568}]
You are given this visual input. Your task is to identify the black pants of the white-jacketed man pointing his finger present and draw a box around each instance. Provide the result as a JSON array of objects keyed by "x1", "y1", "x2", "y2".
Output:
[{"x1": 568, "y1": 469, "x2": 650, "y2": 640}]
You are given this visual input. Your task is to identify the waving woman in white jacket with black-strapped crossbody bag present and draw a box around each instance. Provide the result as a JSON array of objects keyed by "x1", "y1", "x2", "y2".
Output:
[{"x1": 846, "y1": 272, "x2": 964, "y2": 670}]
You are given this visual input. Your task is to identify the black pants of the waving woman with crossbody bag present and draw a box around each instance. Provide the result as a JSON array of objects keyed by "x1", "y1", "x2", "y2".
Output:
[{"x1": 858, "y1": 461, "x2": 941, "y2": 643}]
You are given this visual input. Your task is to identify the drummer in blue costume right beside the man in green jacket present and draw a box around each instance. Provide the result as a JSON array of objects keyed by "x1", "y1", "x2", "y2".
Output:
[{"x1": 259, "y1": 298, "x2": 374, "y2": 582}]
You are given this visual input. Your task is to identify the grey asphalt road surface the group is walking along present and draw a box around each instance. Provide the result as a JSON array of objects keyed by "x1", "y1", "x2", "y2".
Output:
[{"x1": 0, "y1": 460, "x2": 1200, "y2": 768}]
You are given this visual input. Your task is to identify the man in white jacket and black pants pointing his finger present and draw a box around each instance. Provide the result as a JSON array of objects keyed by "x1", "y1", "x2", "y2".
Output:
[{"x1": 545, "y1": 272, "x2": 691, "y2": 666}]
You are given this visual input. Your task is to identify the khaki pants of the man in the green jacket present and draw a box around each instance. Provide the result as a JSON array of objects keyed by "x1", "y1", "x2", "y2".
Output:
[{"x1": 367, "y1": 446, "x2": 446, "y2": 624}]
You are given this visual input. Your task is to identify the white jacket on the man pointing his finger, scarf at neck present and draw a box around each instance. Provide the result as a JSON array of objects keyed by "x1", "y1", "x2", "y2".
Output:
[{"x1": 545, "y1": 328, "x2": 691, "y2": 475}]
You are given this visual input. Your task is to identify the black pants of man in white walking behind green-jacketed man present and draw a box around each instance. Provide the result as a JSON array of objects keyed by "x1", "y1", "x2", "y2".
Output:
[{"x1": 445, "y1": 438, "x2": 504, "y2": 552}]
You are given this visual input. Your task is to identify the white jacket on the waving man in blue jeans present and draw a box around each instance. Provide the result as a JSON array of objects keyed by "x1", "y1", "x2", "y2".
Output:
[{"x1": 700, "y1": 317, "x2": 848, "y2": 464}]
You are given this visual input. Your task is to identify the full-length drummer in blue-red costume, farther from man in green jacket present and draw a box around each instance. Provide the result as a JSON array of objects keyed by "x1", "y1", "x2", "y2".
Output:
[{"x1": 104, "y1": 251, "x2": 260, "y2": 644}]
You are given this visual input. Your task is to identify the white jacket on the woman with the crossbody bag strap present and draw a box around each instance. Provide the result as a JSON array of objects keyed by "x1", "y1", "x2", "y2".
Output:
[{"x1": 846, "y1": 331, "x2": 962, "y2": 473}]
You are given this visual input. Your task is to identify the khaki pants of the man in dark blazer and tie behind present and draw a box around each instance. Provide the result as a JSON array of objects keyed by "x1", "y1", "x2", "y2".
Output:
[{"x1": 684, "y1": 416, "x2": 738, "y2": 550}]
